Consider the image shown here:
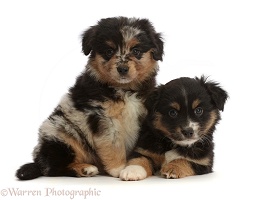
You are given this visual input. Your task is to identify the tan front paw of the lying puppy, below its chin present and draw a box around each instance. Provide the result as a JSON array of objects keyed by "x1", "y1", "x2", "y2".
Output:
[{"x1": 160, "y1": 159, "x2": 195, "y2": 178}]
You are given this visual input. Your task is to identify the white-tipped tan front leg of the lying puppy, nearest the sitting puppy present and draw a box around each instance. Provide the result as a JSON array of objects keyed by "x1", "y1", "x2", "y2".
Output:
[{"x1": 120, "y1": 157, "x2": 153, "y2": 181}]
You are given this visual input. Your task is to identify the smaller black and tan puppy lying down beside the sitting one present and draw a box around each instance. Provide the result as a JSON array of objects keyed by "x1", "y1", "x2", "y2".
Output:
[{"x1": 120, "y1": 76, "x2": 228, "y2": 180}]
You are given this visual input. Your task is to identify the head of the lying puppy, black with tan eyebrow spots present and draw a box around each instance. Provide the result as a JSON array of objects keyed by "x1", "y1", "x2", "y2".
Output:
[{"x1": 146, "y1": 77, "x2": 228, "y2": 146}]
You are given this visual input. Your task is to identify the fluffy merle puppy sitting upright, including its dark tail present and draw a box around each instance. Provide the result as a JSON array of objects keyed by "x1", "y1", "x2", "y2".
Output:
[{"x1": 16, "y1": 17, "x2": 163, "y2": 180}]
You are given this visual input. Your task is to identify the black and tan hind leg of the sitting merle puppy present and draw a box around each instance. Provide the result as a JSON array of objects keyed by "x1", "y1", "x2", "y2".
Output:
[{"x1": 33, "y1": 138, "x2": 98, "y2": 177}]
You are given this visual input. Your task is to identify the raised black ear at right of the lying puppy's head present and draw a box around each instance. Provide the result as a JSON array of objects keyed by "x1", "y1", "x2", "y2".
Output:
[{"x1": 196, "y1": 76, "x2": 228, "y2": 111}]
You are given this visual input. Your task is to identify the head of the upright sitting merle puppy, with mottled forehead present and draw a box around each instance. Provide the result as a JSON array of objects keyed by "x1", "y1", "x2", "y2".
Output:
[{"x1": 82, "y1": 17, "x2": 163, "y2": 85}]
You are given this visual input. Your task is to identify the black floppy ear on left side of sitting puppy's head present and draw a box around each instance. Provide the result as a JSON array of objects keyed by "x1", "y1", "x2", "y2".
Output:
[{"x1": 81, "y1": 26, "x2": 97, "y2": 56}]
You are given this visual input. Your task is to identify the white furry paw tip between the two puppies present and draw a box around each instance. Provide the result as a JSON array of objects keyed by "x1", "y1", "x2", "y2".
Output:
[{"x1": 120, "y1": 165, "x2": 147, "y2": 181}]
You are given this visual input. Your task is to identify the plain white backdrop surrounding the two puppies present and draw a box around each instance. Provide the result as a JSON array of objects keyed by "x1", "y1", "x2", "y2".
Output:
[{"x1": 0, "y1": 0, "x2": 254, "y2": 199}]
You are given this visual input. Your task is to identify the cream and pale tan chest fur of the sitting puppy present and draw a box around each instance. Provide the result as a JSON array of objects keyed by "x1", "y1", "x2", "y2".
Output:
[{"x1": 100, "y1": 91, "x2": 146, "y2": 153}]
